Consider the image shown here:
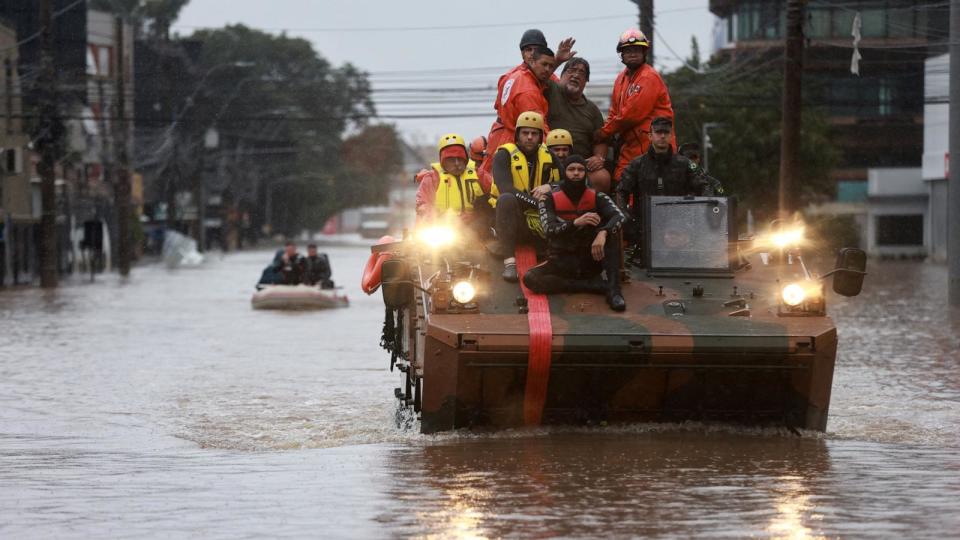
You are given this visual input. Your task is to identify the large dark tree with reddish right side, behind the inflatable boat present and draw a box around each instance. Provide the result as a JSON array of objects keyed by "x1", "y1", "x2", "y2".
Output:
[{"x1": 181, "y1": 25, "x2": 390, "y2": 234}]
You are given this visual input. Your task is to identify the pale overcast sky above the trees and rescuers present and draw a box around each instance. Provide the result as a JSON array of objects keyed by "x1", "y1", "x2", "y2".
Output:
[{"x1": 174, "y1": 0, "x2": 715, "y2": 143}]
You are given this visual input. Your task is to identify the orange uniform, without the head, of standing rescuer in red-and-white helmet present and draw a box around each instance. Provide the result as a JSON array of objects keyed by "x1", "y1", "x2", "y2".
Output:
[{"x1": 600, "y1": 64, "x2": 677, "y2": 178}]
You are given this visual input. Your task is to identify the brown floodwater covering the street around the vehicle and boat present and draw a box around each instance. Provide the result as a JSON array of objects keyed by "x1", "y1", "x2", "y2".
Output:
[{"x1": 0, "y1": 247, "x2": 960, "y2": 538}]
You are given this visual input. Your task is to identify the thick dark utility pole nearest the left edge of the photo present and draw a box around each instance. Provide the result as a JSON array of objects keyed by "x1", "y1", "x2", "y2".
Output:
[{"x1": 37, "y1": 0, "x2": 59, "y2": 289}]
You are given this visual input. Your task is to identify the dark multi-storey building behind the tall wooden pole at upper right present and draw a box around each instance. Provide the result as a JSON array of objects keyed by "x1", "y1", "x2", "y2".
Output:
[{"x1": 710, "y1": 0, "x2": 949, "y2": 194}]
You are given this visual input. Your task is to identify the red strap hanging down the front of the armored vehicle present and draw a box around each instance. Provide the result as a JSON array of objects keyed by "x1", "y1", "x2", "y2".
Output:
[{"x1": 516, "y1": 246, "x2": 553, "y2": 426}]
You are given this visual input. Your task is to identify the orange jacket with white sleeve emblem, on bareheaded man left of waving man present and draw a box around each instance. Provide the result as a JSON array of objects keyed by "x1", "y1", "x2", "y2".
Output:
[{"x1": 480, "y1": 64, "x2": 549, "y2": 173}]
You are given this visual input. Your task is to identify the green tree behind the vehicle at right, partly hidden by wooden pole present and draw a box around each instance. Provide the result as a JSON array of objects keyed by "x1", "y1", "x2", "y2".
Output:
[{"x1": 664, "y1": 48, "x2": 839, "y2": 218}]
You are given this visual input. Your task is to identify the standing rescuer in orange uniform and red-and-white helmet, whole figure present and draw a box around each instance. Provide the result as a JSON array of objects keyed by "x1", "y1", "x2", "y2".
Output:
[{"x1": 594, "y1": 28, "x2": 677, "y2": 179}]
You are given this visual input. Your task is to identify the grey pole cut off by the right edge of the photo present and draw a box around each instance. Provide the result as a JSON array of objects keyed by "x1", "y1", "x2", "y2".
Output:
[{"x1": 947, "y1": 0, "x2": 960, "y2": 307}]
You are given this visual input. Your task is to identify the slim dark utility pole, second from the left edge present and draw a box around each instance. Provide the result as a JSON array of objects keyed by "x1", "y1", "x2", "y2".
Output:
[{"x1": 113, "y1": 17, "x2": 132, "y2": 276}]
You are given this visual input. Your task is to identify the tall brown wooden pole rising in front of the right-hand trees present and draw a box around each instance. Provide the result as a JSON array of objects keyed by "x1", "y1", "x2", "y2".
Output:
[{"x1": 778, "y1": 0, "x2": 805, "y2": 219}]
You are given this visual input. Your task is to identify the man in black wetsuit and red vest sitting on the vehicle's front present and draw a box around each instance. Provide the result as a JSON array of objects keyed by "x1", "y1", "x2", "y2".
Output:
[{"x1": 523, "y1": 155, "x2": 627, "y2": 311}]
